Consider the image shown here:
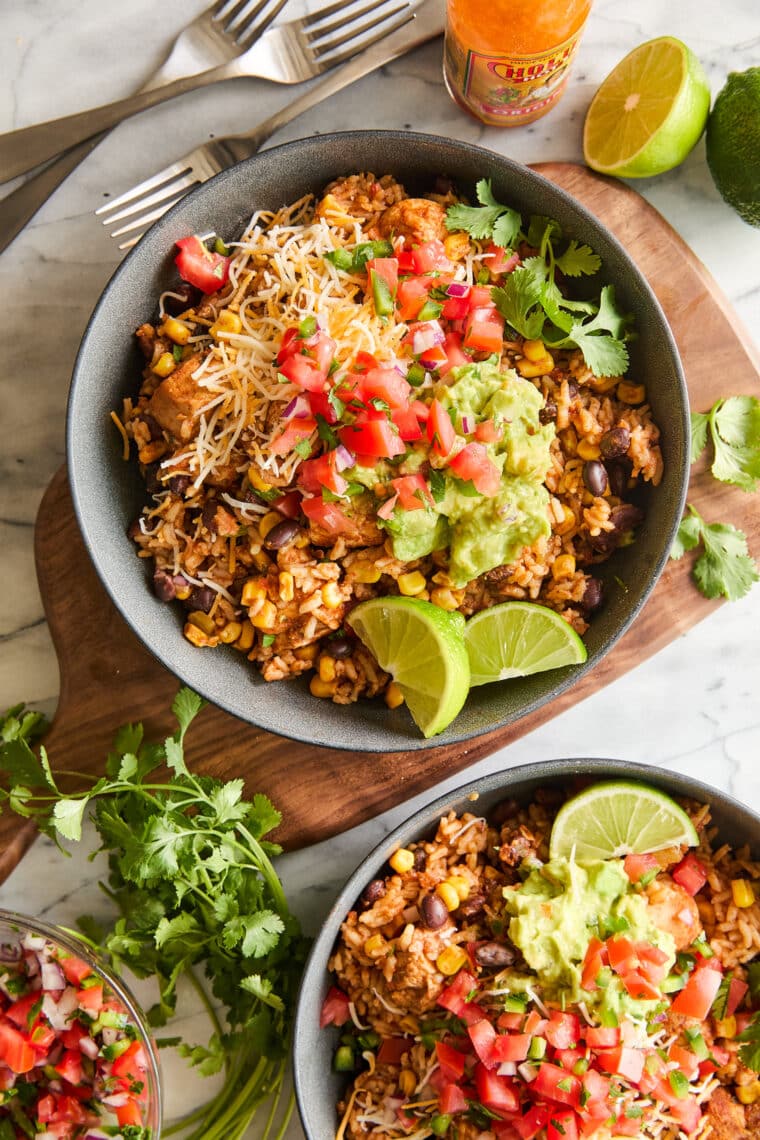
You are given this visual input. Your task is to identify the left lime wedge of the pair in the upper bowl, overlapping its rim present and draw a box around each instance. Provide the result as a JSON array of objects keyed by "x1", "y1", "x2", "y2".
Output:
[{"x1": 349, "y1": 597, "x2": 469, "y2": 736}]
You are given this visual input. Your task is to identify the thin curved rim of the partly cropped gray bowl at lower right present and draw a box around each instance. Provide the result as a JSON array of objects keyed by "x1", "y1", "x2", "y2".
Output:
[{"x1": 291, "y1": 756, "x2": 760, "y2": 1140}]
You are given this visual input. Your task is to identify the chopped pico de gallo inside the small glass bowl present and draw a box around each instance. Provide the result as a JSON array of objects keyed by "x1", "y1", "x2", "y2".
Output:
[{"x1": 0, "y1": 925, "x2": 152, "y2": 1140}]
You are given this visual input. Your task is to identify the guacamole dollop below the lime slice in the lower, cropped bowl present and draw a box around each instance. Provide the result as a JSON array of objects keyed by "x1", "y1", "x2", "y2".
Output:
[{"x1": 504, "y1": 858, "x2": 676, "y2": 1016}]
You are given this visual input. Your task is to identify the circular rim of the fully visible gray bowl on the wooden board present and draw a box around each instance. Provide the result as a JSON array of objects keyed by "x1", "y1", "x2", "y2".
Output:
[{"x1": 66, "y1": 129, "x2": 690, "y2": 752}]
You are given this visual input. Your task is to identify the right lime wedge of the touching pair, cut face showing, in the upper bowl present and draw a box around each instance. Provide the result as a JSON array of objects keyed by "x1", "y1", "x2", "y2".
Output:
[{"x1": 465, "y1": 602, "x2": 587, "y2": 685}]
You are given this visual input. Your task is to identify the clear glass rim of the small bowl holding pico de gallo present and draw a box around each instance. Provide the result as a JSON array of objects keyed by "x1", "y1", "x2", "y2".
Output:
[{"x1": 0, "y1": 907, "x2": 162, "y2": 1140}]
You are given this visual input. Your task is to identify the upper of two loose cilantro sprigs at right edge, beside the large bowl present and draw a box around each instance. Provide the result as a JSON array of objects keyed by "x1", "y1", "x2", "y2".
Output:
[{"x1": 692, "y1": 396, "x2": 760, "y2": 491}]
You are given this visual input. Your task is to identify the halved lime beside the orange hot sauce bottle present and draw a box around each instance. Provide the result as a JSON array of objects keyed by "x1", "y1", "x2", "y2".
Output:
[{"x1": 583, "y1": 35, "x2": 710, "y2": 178}]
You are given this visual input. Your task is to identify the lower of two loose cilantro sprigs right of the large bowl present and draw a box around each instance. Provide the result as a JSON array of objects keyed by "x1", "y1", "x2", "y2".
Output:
[{"x1": 670, "y1": 504, "x2": 760, "y2": 602}]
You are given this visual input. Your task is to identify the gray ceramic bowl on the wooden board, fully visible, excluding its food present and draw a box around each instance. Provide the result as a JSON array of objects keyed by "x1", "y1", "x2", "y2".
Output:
[{"x1": 67, "y1": 131, "x2": 688, "y2": 752}]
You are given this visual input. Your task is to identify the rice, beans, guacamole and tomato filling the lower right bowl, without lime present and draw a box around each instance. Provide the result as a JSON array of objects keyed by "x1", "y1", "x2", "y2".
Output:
[{"x1": 321, "y1": 798, "x2": 760, "y2": 1140}]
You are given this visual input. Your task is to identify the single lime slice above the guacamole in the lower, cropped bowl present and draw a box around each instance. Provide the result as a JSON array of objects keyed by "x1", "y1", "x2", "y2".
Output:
[{"x1": 549, "y1": 780, "x2": 700, "y2": 863}]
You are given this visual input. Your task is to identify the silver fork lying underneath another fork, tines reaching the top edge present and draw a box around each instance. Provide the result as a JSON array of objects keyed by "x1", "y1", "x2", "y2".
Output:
[{"x1": 0, "y1": 0, "x2": 286, "y2": 252}]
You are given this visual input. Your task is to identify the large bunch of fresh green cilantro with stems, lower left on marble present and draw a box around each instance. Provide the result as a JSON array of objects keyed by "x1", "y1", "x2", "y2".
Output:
[{"x1": 0, "y1": 689, "x2": 308, "y2": 1140}]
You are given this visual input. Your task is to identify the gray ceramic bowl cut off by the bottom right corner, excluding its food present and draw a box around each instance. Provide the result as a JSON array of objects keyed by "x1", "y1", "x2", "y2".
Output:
[{"x1": 293, "y1": 759, "x2": 760, "y2": 1140}]
